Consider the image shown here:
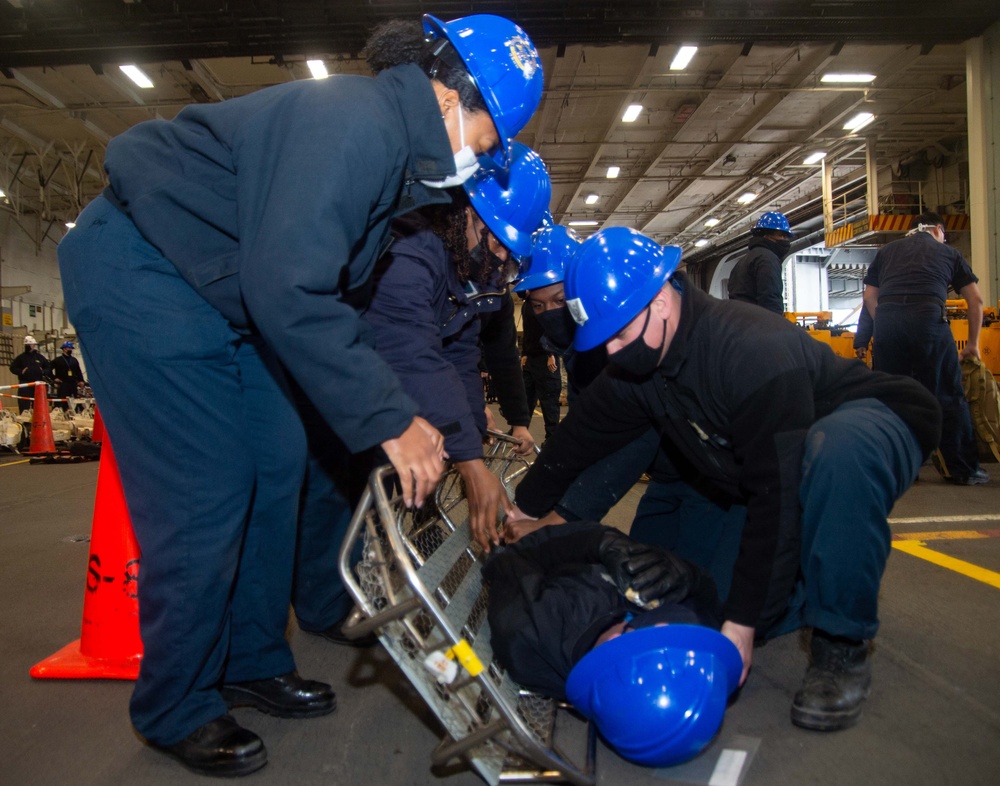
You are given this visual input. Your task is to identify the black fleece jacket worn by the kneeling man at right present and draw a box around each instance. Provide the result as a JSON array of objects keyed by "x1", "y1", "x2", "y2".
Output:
[{"x1": 516, "y1": 273, "x2": 941, "y2": 629}]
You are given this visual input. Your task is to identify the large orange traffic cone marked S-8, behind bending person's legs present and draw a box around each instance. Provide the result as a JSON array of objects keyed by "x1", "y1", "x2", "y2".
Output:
[{"x1": 30, "y1": 436, "x2": 142, "y2": 680}]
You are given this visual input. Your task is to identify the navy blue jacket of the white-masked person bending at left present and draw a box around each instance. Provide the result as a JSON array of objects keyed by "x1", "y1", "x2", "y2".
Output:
[{"x1": 105, "y1": 65, "x2": 455, "y2": 452}]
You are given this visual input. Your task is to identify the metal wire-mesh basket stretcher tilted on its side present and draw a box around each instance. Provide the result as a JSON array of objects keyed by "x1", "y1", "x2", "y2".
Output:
[{"x1": 340, "y1": 434, "x2": 595, "y2": 786}]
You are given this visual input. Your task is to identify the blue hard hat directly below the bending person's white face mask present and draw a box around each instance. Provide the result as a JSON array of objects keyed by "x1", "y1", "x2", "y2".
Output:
[{"x1": 462, "y1": 142, "x2": 552, "y2": 259}]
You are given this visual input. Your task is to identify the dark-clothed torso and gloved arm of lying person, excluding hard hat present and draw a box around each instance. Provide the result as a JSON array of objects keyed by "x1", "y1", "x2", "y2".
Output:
[{"x1": 483, "y1": 521, "x2": 722, "y2": 699}]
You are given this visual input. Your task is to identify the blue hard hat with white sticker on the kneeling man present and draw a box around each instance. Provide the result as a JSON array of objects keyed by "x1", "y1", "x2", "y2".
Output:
[{"x1": 565, "y1": 227, "x2": 681, "y2": 352}]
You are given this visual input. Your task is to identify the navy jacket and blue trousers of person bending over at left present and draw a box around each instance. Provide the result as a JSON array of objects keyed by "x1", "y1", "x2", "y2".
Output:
[{"x1": 59, "y1": 65, "x2": 454, "y2": 745}]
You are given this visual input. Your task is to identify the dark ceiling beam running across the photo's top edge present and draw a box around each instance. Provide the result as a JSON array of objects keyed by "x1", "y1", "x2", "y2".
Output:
[{"x1": 0, "y1": 0, "x2": 1000, "y2": 68}]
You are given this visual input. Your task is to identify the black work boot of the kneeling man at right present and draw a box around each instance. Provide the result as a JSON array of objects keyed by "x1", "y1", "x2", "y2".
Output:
[{"x1": 792, "y1": 630, "x2": 872, "y2": 731}]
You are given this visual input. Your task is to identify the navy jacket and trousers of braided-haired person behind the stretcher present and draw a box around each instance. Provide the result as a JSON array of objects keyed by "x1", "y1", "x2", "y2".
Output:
[{"x1": 294, "y1": 211, "x2": 524, "y2": 631}]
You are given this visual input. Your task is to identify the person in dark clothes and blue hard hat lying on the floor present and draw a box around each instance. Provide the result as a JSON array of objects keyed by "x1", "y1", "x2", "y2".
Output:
[{"x1": 483, "y1": 521, "x2": 742, "y2": 767}]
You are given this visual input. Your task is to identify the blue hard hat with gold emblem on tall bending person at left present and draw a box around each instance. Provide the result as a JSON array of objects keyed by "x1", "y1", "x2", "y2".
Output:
[{"x1": 424, "y1": 14, "x2": 543, "y2": 162}]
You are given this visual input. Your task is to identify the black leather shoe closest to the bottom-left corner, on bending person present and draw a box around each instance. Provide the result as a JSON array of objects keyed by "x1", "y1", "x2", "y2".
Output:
[{"x1": 152, "y1": 715, "x2": 267, "y2": 778}]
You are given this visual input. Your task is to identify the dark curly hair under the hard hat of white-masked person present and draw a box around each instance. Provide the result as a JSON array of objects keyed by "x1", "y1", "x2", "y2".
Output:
[{"x1": 361, "y1": 19, "x2": 487, "y2": 112}]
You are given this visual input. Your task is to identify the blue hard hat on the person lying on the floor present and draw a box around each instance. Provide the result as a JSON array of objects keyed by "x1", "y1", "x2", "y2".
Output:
[{"x1": 566, "y1": 625, "x2": 743, "y2": 767}]
